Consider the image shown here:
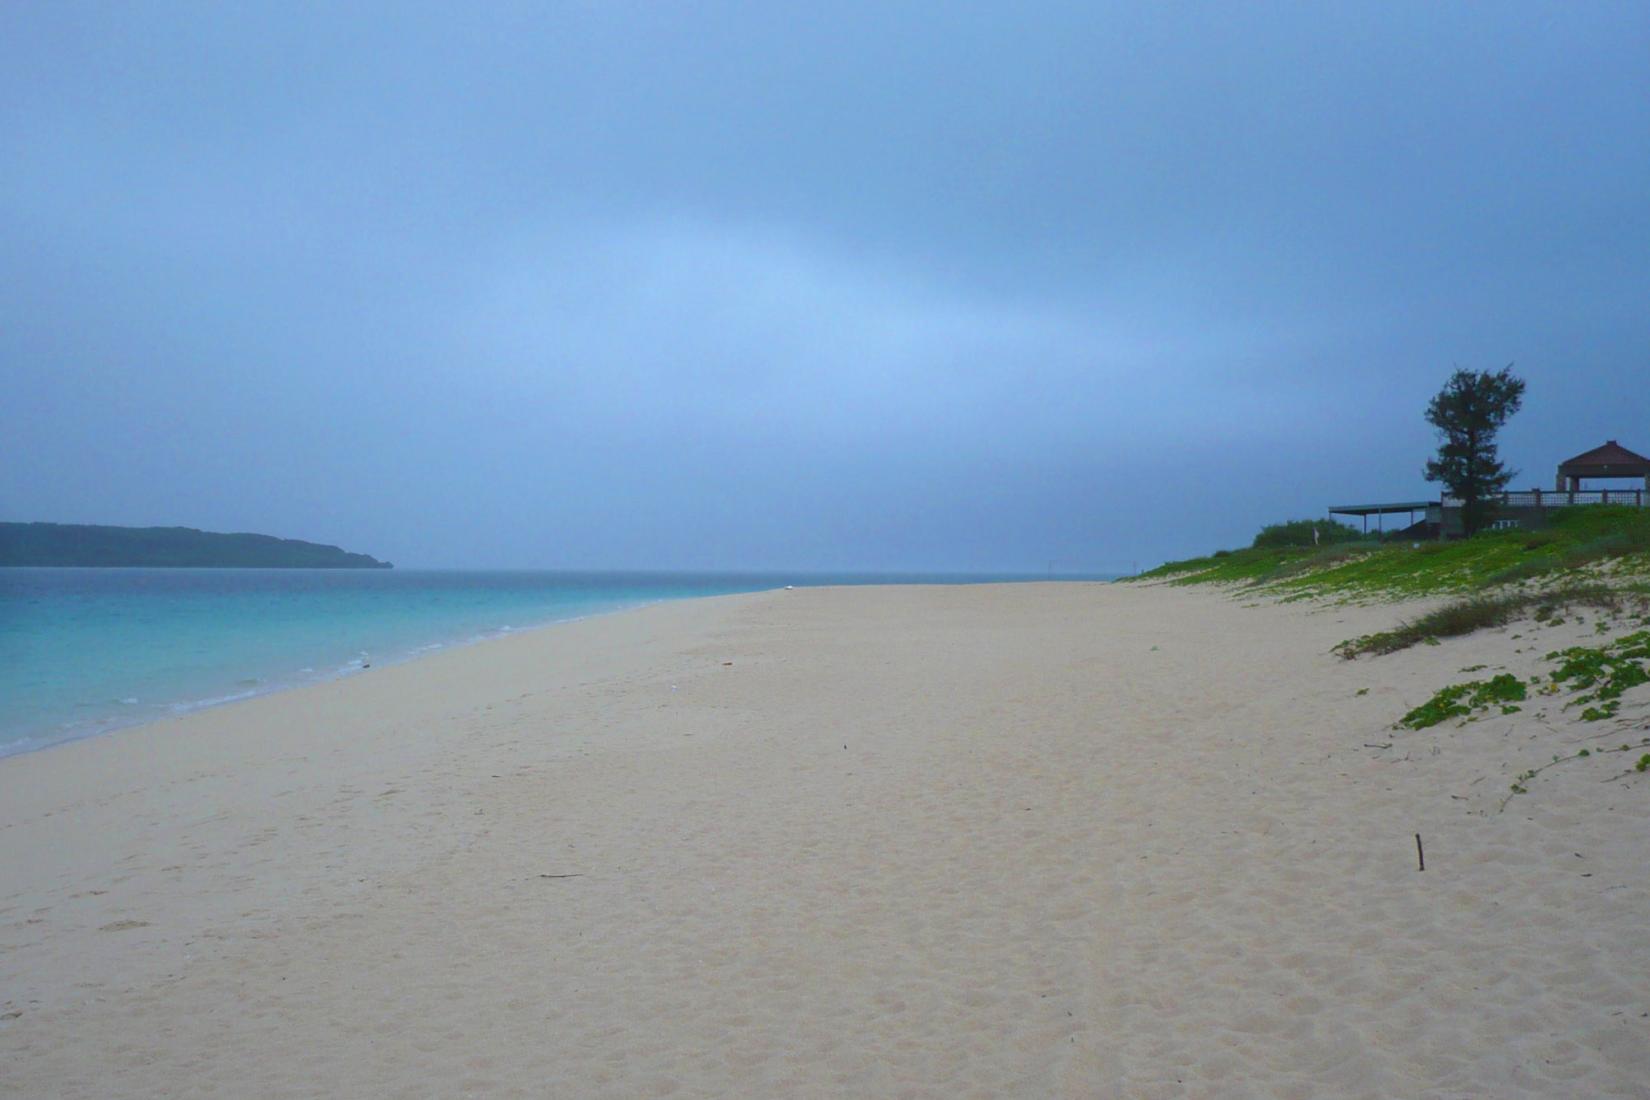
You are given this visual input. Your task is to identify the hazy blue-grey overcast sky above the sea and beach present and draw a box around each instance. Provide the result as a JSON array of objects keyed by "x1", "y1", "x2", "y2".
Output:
[{"x1": 0, "y1": 0, "x2": 1650, "y2": 571}]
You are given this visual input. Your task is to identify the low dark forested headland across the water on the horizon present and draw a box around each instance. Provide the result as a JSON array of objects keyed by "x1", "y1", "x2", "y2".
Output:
[{"x1": 0, "y1": 523, "x2": 391, "y2": 569}]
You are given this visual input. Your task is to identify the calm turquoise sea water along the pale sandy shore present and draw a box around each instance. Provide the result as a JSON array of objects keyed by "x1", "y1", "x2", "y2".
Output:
[{"x1": 0, "y1": 569, "x2": 1108, "y2": 755}]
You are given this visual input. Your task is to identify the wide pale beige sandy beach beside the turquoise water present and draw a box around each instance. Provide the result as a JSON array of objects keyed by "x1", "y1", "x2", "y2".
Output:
[{"x1": 0, "y1": 584, "x2": 1650, "y2": 1097}]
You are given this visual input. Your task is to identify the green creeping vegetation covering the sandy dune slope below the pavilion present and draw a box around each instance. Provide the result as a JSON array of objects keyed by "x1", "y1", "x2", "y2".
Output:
[{"x1": 1137, "y1": 506, "x2": 1650, "y2": 791}]
